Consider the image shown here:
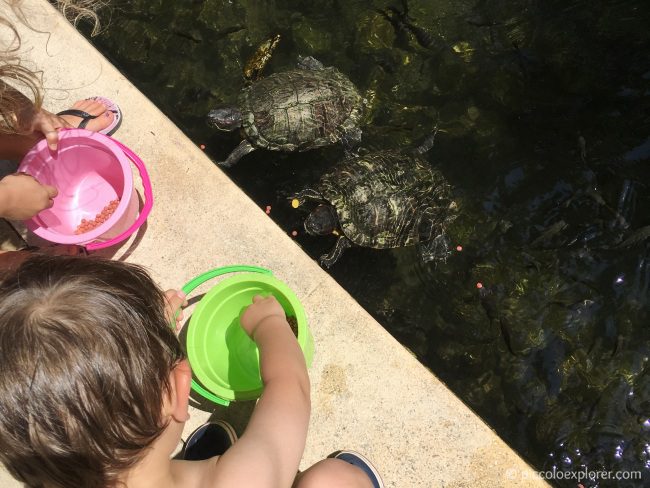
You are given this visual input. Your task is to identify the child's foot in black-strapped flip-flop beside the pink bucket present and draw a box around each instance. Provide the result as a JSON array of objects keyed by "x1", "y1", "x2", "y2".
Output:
[{"x1": 57, "y1": 97, "x2": 122, "y2": 135}]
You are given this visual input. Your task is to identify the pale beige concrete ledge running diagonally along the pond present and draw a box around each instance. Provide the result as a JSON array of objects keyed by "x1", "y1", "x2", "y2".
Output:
[{"x1": 0, "y1": 0, "x2": 546, "y2": 488}]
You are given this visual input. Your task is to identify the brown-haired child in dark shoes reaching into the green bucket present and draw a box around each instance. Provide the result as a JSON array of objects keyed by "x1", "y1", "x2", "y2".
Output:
[{"x1": 0, "y1": 255, "x2": 383, "y2": 488}]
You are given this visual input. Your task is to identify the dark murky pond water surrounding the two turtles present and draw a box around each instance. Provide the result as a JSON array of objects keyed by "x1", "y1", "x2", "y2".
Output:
[{"x1": 86, "y1": 0, "x2": 650, "y2": 487}]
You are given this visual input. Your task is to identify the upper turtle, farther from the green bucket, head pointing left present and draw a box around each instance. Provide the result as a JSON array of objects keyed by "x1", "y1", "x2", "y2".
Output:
[{"x1": 207, "y1": 56, "x2": 365, "y2": 167}]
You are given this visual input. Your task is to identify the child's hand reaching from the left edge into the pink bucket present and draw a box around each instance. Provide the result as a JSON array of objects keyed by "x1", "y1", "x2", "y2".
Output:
[{"x1": 0, "y1": 173, "x2": 59, "y2": 220}]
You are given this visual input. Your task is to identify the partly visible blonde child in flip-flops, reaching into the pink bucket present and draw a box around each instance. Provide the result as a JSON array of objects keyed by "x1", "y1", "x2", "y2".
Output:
[{"x1": 0, "y1": 4, "x2": 121, "y2": 220}]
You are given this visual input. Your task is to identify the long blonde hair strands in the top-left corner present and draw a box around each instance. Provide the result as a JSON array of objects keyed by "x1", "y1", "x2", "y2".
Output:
[{"x1": 0, "y1": 0, "x2": 108, "y2": 134}]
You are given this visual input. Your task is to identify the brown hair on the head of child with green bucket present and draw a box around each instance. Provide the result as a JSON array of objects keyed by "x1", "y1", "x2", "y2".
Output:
[{"x1": 0, "y1": 255, "x2": 185, "y2": 488}]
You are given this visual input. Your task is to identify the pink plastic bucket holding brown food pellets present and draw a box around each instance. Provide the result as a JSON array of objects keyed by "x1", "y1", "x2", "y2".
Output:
[{"x1": 18, "y1": 129, "x2": 153, "y2": 251}]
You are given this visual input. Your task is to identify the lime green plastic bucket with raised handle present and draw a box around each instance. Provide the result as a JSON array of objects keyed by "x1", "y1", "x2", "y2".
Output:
[{"x1": 178, "y1": 266, "x2": 314, "y2": 406}]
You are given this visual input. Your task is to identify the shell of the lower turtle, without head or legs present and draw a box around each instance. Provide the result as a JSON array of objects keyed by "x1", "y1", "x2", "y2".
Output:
[{"x1": 318, "y1": 150, "x2": 454, "y2": 249}]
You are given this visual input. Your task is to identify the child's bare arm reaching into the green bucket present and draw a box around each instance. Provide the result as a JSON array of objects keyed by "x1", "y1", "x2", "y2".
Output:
[{"x1": 209, "y1": 296, "x2": 311, "y2": 488}]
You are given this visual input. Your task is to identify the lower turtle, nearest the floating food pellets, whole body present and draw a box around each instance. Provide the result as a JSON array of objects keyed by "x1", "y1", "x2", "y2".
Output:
[{"x1": 292, "y1": 133, "x2": 457, "y2": 268}]
